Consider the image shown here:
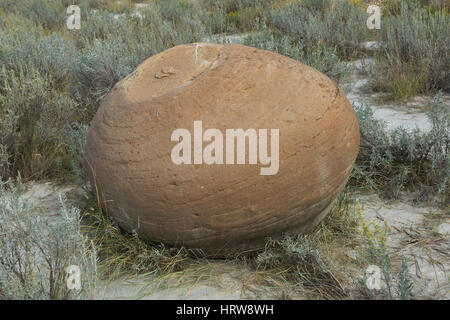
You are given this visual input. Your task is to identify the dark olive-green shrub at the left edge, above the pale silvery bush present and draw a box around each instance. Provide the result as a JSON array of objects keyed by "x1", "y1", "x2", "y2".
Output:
[{"x1": 0, "y1": 68, "x2": 76, "y2": 179}]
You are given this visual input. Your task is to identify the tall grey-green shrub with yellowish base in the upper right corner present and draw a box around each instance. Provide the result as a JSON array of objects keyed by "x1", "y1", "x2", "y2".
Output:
[{"x1": 371, "y1": 5, "x2": 450, "y2": 99}]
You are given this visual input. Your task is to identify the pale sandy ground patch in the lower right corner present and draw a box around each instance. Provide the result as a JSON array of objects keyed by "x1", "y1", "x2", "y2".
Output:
[{"x1": 355, "y1": 194, "x2": 450, "y2": 299}]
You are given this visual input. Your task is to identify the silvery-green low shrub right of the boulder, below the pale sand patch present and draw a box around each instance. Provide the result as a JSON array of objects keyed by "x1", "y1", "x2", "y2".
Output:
[{"x1": 353, "y1": 94, "x2": 450, "y2": 204}]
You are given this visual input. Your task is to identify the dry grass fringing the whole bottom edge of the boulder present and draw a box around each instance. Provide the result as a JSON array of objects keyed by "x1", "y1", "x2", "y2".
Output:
[{"x1": 84, "y1": 182, "x2": 356, "y2": 299}]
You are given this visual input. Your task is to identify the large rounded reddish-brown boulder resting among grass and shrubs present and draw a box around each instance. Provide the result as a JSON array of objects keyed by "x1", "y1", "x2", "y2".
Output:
[{"x1": 86, "y1": 43, "x2": 359, "y2": 256}]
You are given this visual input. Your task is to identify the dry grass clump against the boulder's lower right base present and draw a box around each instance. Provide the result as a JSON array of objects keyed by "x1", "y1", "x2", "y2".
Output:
[{"x1": 244, "y1": 188, "x2": 358, "y2": 299}]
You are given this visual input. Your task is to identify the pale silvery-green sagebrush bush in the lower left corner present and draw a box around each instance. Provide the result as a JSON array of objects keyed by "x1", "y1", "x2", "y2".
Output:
[{"x1": 0, "y1": 181, "x2": 97, "y2": 300}]
